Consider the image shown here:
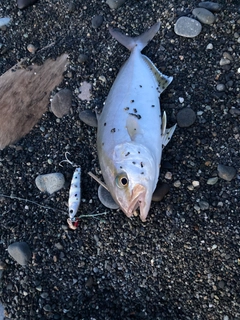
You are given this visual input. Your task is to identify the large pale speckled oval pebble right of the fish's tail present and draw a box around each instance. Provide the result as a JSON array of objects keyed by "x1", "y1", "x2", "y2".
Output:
[{"x1": 174, "y1": 17, "x2": 202, "y2": 38}]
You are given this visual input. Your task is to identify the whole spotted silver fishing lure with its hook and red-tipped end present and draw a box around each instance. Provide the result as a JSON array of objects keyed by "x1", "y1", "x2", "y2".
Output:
[{"x1": 60, "y1": 152, "x2": 81, "y2": 230}]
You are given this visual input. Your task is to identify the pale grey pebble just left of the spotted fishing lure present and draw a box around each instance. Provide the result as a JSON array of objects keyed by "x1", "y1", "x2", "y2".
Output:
[{"x1": 35, "y1": 172, "x2": 65, "y2": 194}]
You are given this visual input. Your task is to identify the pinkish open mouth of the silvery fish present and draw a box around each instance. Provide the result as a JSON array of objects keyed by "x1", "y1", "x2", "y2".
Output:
[{"x1": 126, "y1": 184, "x2": 147, "y2": 220}]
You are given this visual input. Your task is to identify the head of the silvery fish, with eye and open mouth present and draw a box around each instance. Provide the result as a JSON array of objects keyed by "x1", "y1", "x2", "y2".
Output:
[{"x1": 102, "y1": 142, "x2": 159, "y2": 221}]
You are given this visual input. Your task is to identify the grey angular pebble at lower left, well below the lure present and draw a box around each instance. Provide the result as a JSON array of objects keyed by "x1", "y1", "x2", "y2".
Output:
[{"x1": 7, "y1": 242, "x2": 32, "y2": 266}]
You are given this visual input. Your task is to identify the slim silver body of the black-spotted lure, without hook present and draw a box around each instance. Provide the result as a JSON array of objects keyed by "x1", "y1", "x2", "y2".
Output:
[{"x1": 68, "y1": 168, "x2": 81, "y2": 222}]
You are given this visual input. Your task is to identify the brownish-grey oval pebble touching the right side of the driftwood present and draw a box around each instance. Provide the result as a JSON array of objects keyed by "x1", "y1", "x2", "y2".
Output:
[{"x1": 51, "y1": 89, "x2": 72, "y2": 118}]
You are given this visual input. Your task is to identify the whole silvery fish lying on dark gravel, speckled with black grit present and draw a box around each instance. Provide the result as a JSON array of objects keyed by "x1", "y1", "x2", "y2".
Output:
[{"x1": 97, "y1": 22, "x2": 176, "y2": 222}]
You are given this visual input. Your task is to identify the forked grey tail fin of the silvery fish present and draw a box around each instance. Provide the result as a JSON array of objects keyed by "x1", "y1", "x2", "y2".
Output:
[{"x1": 109, "y1": 22, "x2": 160, "y2": 51}]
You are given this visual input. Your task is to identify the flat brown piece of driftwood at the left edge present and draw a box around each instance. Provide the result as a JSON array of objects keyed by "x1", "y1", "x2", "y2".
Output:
[{"x1": 0, "y1": 54, "x2": 68, "y2": 149}]
